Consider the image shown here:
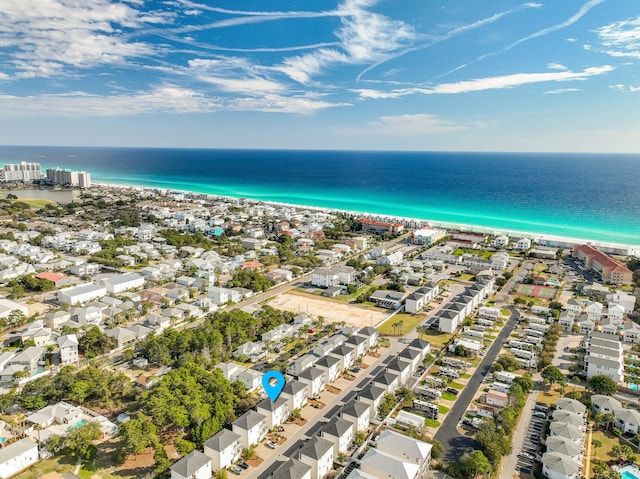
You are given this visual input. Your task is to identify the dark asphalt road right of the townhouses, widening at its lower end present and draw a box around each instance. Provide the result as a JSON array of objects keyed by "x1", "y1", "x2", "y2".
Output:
[{"x1": 434, "y1": 307, "x2": 520, "y2": 462}]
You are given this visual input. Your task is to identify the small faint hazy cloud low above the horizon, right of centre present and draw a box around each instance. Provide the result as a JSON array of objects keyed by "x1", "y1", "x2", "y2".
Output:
[{"x1": 362, "y1": 113, "x2": 469, "y2": 137}]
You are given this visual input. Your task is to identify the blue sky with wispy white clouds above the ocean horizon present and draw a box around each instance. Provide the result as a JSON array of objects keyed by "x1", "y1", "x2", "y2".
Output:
[{"x1": 0, "y1": 0, "x2": 640, "y2": 152}]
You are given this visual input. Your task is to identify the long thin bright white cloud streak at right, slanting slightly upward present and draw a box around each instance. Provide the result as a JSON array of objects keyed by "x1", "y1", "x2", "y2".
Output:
[{"x1": 357, "y1": 65, "x2": 614, "y2": 99}]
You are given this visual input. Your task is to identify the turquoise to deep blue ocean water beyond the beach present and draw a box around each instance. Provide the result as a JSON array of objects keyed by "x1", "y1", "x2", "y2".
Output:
[{"x1": 0, "y1": 147, "x2": 640, "y2": 245}]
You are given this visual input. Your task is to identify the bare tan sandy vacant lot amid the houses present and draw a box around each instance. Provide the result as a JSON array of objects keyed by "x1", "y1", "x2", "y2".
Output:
[{"x1": 269, "y1": 293, "x2": 389, "y2": 328}]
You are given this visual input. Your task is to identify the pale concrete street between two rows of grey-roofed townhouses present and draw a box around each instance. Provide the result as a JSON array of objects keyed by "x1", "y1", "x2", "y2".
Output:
[{"x1": 251, "y1": 339, "x2": 405, "y2": 479}]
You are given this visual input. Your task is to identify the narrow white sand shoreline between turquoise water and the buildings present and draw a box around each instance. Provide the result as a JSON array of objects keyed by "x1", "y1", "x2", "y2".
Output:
[{"x1": 91, "y1": 182, "x2": 640, "y2": 255}]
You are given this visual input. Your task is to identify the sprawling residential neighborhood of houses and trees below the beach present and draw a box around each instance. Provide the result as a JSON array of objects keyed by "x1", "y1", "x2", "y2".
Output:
[{"x1": 0, "y1": 177, "x2": 640, "y2": 479}]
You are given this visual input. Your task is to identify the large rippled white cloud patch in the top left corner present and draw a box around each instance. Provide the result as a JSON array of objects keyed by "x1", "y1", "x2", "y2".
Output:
[{"x1": 0, "y1": 0, "x2": 172, "y2": 78}]
